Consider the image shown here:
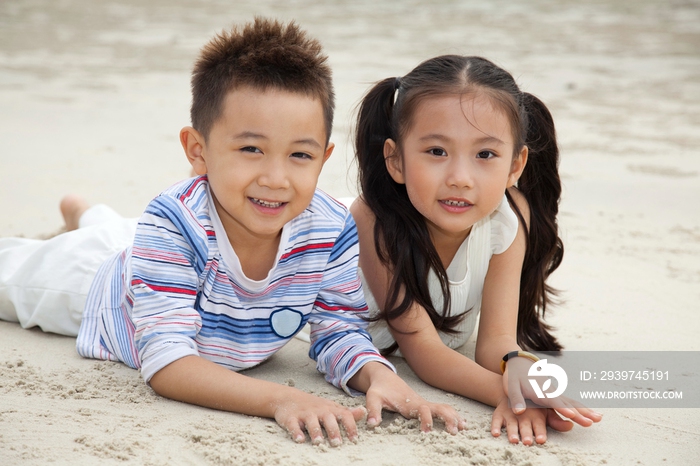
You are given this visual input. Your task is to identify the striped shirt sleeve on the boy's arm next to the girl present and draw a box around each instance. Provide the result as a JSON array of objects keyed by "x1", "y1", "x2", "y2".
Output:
[{"x1": 309, "y1": 214, "x2": 396, "y2": 395}]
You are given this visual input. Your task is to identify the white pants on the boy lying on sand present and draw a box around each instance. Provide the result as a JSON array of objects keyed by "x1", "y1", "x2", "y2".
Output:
[{"x1": 0, "y1": 205, "x2": 137, "y2": 336}]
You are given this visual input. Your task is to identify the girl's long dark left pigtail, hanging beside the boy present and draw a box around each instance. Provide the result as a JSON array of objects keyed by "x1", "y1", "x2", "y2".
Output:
[{"x1": 355, "y1": 78, "x2": 464, "y2": 354}]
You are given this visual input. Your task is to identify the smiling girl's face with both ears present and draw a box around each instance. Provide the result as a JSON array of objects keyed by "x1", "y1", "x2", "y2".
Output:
[{"x1": 384, "y1": 94, "x2": 527, "y2": 248}]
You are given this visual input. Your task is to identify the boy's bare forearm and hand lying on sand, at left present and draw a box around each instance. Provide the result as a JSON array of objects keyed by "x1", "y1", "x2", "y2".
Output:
[{"x1": 150, "y1": 356, "x2": 365, "y2": 446}]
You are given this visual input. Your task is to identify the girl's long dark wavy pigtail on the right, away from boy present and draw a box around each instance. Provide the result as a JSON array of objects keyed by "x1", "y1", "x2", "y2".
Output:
[{"x1": 508, "y1": 93, "x2": 564, "y2": 351}]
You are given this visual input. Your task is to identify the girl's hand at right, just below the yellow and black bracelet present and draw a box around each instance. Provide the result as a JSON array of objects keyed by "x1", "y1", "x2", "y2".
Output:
[{"x1": 503, "y1": 358, "x2": 603, "y2": 431}]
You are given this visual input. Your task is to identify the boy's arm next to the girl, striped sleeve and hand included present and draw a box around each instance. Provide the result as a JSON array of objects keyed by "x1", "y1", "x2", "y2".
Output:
[{"x1": 309, "y1": 216, "x2": 465, "y2": 433}]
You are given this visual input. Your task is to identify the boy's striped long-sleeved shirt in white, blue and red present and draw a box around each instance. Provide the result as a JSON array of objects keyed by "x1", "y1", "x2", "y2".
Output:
[{"x1": 77, "y1": 177, "x2": 393, "y2": 393}]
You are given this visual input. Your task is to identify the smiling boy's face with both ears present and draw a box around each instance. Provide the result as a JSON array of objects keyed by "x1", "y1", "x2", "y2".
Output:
[{"x1": 181, "y1": 87, "x2": 333, "y2": 246}]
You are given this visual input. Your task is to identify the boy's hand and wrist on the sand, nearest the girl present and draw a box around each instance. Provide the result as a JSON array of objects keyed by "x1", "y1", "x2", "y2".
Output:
[{"x1": 351, "y1": 362, "x2": 466, "y2": 435}]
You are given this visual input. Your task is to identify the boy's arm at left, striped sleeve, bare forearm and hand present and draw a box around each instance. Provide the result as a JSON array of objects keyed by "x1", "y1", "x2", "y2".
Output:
[{"x1": 128, "y1": 196, "x2": 364, "y2": 445}]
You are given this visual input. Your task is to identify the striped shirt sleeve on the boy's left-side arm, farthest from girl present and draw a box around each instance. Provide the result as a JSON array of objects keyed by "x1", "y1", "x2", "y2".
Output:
[{"x1": 128, "y1": 196, "x2": 207, "y2": 382}]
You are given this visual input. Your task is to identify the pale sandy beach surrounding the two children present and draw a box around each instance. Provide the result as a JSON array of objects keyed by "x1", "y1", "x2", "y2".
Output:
[{"x1": 0, "y1": 0, "x2": 700, "y2": 466}]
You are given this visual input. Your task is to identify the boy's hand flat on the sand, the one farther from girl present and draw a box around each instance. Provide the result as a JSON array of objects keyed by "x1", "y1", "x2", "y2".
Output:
[{"x1": 275, "y1": 391, "x2": 366, "y2": 447}]
